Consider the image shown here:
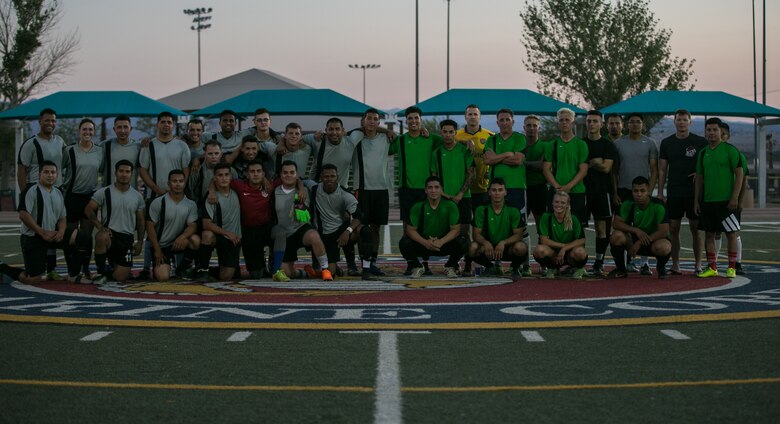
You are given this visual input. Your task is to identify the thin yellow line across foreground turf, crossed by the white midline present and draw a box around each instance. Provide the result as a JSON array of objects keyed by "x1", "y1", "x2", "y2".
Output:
[{"x1": 0, "y1": 377, "x2": 780, "y2": 393}]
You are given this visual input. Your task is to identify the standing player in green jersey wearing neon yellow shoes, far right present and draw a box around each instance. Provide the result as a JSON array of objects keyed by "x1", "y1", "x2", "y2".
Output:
[{"x1": 694, "y1": 118, "x2": 745, "y2": 278}]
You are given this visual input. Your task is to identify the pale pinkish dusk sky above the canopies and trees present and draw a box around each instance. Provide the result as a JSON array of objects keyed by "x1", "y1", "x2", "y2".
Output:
[{"x1": 37, "y1": 0, "x2": 780, "y2": 109}]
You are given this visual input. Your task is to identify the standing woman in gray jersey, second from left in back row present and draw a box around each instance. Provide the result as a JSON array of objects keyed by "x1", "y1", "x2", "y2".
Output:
[{"x1": 63, "y1": 119, "x2": 105, "y2": 276}]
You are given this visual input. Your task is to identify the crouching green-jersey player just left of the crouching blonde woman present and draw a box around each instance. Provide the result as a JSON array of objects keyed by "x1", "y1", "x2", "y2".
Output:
[{"x1": 469, "y1": 177, "x2": 528, "y2": 278}]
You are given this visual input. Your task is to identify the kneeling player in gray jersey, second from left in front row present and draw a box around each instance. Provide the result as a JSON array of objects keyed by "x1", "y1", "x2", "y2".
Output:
[{"x1": 85, "y1": 160, "x2": 146, "y2": 282}]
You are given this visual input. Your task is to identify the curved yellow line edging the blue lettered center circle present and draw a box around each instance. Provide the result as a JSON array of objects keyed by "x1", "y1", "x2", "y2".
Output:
[{"x1": 0, "y1": 310, "x2": 780, "y2": 330}]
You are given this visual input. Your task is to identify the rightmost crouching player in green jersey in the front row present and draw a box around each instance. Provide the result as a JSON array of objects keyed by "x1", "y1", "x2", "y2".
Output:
[{"x1": 607, "y1": 176, "x2": 672, "y2": 278}]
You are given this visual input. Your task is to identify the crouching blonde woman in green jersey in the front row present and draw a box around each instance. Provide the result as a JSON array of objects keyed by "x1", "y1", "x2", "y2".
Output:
[{"x1": 534, "y1": 191, "x2": 588, "y2": 279}]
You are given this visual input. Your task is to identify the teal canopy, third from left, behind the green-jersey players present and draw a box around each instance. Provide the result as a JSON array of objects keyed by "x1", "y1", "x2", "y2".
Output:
[{"x1": 401, "y1": 88, "x2": 587, "y2": 115}]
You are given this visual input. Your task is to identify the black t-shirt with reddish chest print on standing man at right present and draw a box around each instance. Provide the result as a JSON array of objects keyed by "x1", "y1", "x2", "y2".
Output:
[{"x1": 658, "y1": 133, "x2": 707, "y2": 197}]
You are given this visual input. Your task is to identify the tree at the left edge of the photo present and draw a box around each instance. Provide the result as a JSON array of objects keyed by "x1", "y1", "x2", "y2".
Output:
[{"x1": 0, "y1": 0, "x2": 79, "y2": 110}]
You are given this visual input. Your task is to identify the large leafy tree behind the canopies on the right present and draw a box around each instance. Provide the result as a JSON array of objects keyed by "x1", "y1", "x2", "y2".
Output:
[{"x1": 520, "y1": 0, "x2": 695, "y2": 109}]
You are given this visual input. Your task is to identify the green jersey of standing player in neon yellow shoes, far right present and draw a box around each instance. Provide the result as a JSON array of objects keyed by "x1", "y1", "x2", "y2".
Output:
[{"x1": 696, "y1": 142, "x2": 742, "y2": 202}]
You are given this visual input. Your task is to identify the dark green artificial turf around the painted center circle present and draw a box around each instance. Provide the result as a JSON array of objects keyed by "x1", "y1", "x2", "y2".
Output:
[{"x1": 0, "y1": 223, "x2": 780, "y2": 423}]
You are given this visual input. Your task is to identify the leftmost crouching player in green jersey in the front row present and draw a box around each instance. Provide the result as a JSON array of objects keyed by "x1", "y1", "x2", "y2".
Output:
[{"x1": 398, "y1": 176, "x2": 468, "y2": 278}]
